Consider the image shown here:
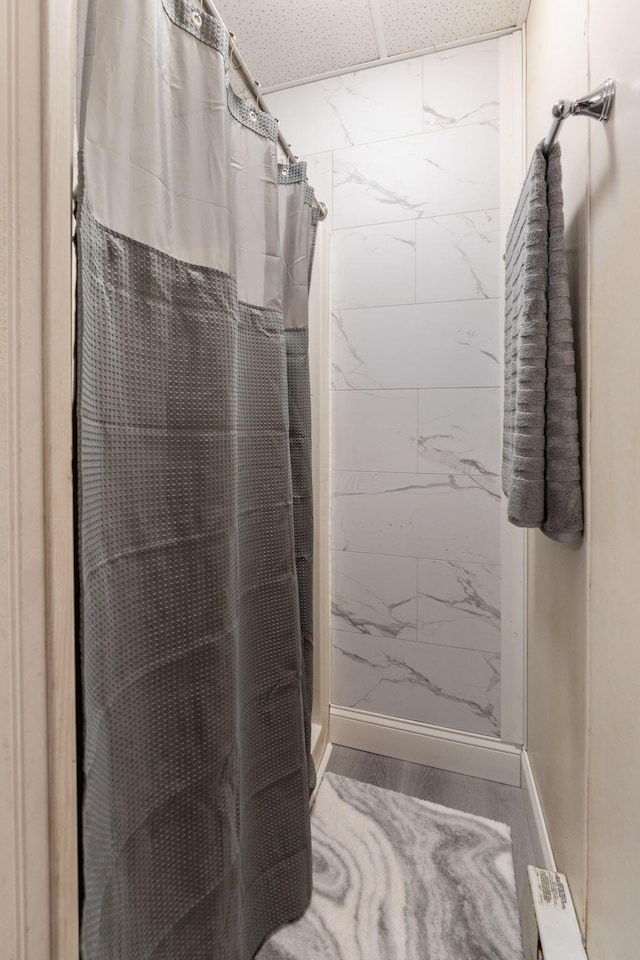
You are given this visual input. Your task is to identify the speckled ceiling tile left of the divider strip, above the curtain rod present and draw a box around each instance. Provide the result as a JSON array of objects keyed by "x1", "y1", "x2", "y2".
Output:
[{"x1": 216, "y1": 0, "x2": 379, "y2": 87}]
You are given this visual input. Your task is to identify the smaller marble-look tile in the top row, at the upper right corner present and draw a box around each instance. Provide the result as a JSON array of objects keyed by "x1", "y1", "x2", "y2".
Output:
[{"x1": 422, "y1": 40, "x2": 500, "y2": 130}]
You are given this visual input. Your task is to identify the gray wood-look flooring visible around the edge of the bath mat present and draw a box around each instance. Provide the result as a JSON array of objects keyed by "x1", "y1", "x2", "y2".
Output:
[{"x1": 327, "y1": 746, "x2": 538, "y2": 960}]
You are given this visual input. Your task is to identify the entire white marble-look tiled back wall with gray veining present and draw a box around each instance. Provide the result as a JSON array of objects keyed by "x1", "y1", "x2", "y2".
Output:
[{"x1": 268, "y1": 40, "x2": 501, "y2": 737}]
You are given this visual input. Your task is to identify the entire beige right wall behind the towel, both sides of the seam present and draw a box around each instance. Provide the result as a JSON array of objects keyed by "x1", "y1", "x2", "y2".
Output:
[{"x1": 527, "y1": 0, "x2": 640, "y2": 960}]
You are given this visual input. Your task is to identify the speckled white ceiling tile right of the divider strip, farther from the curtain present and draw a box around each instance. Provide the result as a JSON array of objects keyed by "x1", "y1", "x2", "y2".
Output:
[{"x1": 377, "y1": 0, "x2": 520, "y2": 56}]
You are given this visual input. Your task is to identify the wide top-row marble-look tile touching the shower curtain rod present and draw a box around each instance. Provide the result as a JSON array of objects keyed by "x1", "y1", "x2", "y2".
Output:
[{"x1": 265, "y1": 57, "x2": 423, "y2": 155}]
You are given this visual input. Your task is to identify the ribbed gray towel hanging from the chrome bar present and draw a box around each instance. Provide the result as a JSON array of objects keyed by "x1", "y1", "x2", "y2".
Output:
[{"x1": 502, "y1": 144, "x2": 583, "y2": 543}]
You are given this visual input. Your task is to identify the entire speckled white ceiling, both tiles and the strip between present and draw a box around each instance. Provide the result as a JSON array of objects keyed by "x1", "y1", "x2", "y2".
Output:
[{"x1": 216, "y1": 0, "x2": 528, "y2": 89}]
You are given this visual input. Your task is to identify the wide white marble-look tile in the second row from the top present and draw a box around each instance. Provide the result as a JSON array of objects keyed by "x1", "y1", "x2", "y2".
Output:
[{"x1": 333, "y1": 121, "x2": 500, "y2": 227}]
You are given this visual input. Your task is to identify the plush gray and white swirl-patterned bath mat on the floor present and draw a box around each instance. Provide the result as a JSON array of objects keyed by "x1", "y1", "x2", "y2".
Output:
[{"x1": 258, "y1": 774, "x2": 522, "y2": 960}]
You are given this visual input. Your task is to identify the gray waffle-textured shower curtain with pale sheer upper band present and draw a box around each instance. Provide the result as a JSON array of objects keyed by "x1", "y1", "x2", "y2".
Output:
[{"x1": 76, "y1": 0, "x2": 317, "y2": 960}]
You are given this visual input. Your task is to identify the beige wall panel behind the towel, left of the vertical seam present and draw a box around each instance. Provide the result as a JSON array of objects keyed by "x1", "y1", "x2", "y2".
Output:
[{"x1": 526, "y1": 0, "x2": 589, "y2": 919}]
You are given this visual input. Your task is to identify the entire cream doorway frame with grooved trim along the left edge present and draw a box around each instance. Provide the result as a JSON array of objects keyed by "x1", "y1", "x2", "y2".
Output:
[{"x1": 0, "y1": 0, "x2": 78, "y2": 960}]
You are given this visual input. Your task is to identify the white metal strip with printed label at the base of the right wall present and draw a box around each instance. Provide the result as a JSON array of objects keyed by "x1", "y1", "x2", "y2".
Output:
[{"x1": 528, "y1": 867, "x2": 587, "y2": 960}]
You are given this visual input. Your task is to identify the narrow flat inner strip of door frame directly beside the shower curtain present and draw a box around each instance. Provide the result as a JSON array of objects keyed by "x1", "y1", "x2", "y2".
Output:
[{"x1": 42, "y1": 0, "x2": 80, "y2": 960}]
